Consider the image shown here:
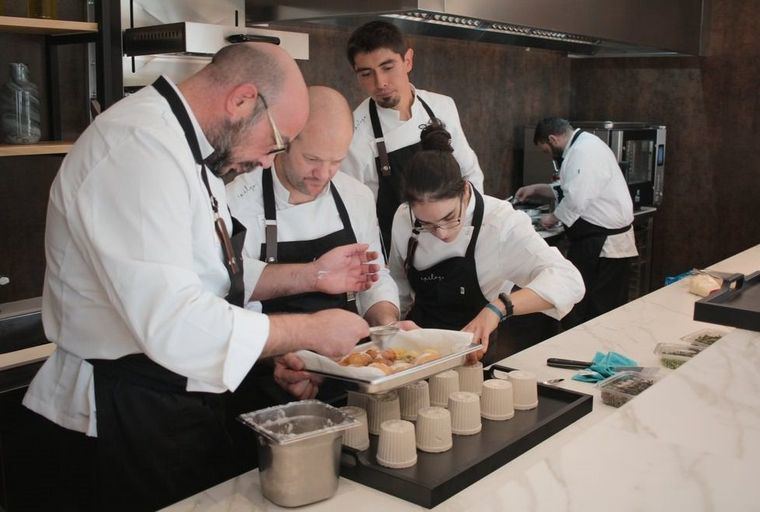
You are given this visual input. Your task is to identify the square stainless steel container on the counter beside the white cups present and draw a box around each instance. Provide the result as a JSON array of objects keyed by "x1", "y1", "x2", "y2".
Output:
[{"x1": 240, "y1": 400, "x2": 358, "y2": 507}]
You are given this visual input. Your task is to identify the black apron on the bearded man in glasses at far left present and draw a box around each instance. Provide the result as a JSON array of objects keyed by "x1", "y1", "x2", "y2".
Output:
[{"x1": 89, "y1": 77, "x2": 245, "y2": 511}]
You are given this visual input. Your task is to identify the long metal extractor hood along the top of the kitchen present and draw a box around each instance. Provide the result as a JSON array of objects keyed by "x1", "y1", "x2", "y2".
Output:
[{"x1": 245, "y1": 0, "x2": 708, "y2": 56}]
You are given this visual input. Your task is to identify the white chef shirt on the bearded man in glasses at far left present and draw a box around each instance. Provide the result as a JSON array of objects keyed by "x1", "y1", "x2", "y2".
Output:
[{"x1": 23, "y1": 77, "x2": 269, "y2": 436}]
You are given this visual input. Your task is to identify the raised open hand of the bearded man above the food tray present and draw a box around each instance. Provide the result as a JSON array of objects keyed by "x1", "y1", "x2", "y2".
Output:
[{"x1": 313, "y1": 244, "x2": 380, "y2": 294}]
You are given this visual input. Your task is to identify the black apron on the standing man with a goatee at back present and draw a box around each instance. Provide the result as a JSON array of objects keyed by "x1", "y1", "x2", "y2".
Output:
[{"x1": 369, "y1": 94, "x2": 435, "y2": 261}]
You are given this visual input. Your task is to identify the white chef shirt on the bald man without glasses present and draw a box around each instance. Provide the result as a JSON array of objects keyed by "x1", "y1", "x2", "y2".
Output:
[{"x1": 227, "y1": 164, "x2": 398, "y2": 315}]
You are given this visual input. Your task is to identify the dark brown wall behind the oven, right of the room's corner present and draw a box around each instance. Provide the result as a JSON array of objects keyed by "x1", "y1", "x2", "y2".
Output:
[{"x1": 571, "y1": 0, "x2": 760, "y2": 285}]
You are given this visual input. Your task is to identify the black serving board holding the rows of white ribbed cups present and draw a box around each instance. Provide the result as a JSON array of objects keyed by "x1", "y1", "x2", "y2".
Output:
[{"x1": 340, "y1": 365, "x2": 593, "y2": 508}]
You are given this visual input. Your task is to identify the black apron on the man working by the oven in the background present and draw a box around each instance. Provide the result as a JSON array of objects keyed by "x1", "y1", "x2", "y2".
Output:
[{"x1": 559, "y1": 130, "x2": 631, "y2": 328}]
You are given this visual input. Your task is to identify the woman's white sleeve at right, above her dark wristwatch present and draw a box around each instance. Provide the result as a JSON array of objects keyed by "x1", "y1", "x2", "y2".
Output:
[{"x1": 500, "y1": 212, "x2": 585, "y2": 319}]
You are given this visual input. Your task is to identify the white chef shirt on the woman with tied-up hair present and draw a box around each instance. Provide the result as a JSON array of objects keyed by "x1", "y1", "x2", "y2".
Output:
[{"x1": 390, "y1": 184, "x2": 585, "y2": 319}]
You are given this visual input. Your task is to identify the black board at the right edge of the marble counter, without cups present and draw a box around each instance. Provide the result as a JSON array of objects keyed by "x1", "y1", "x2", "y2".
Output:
[{"x1": 694, "y1": 271, "x2": 760, "y2": 331}]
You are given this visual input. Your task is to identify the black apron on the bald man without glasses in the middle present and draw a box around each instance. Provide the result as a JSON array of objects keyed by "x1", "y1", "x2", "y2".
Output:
[{"x1": 259, "y1": 169, "x2": 356, "y2": 314}]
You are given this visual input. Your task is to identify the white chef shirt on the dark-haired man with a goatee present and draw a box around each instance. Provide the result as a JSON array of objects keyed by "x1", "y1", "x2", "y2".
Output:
[{"x1": 341, "y1": 89, "x2": 483, "y2": 200}]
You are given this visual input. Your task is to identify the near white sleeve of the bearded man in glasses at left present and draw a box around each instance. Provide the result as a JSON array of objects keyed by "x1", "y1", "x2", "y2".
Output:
[{"x1": 69, "y1": 129, "x2": 269, "y2": 392}]
